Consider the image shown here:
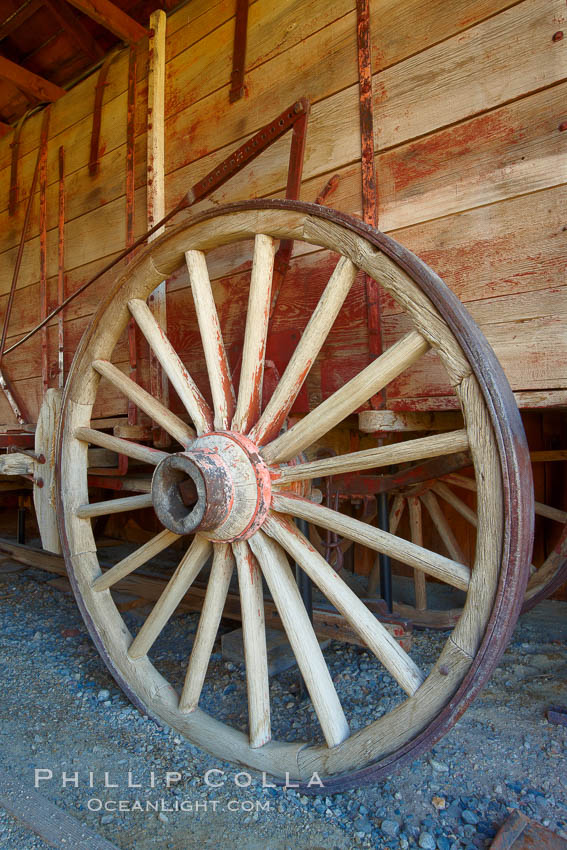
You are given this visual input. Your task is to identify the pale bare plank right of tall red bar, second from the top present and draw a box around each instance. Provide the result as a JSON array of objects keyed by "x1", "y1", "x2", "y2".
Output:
[{"x1": 373, "y1": 0, "x2": 567, "y2": 150}]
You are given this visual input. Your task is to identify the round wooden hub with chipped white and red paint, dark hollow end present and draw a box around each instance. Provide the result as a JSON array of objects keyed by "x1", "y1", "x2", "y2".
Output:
[{"x1": 152, "y1": 431, "x2": 271, "y2": 542}]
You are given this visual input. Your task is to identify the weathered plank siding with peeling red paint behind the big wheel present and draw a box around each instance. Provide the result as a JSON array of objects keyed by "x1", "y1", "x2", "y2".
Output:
[{"x1": 0, "y1": 0, "x2": 567, "y2": 422}]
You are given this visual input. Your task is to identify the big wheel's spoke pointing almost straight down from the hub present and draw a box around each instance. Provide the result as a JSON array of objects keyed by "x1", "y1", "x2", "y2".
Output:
[{"x1": 232, "y1": 540, "x2": 271, "y2": 748}]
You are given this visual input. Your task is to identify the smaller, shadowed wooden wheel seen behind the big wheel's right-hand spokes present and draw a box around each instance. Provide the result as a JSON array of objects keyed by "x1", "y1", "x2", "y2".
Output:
[{"x1": 369, "y1": 451, "x2": 567, "y2": 629}]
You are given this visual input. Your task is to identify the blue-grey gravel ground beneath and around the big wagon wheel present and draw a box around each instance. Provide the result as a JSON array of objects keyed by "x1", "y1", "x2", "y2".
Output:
[{"x1": 0, "y1": 556, "x2": 567, "y2": 850}]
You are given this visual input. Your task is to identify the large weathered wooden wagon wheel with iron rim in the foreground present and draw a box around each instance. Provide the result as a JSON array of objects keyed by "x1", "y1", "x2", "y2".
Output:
[{"x1": 58, "y1": 201, "x2": 533, "y2": 791}]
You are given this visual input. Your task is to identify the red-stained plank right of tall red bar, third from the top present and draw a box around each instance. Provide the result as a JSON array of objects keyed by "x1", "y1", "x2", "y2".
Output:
[{"x1": 376, "y1": 81, "x2": 567, "y2": 230}]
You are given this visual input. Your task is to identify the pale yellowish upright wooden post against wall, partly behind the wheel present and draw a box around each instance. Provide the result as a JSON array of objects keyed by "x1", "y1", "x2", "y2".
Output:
[{"x1": 147, "y1": 9, "x2": 170, "y2": 447}]
